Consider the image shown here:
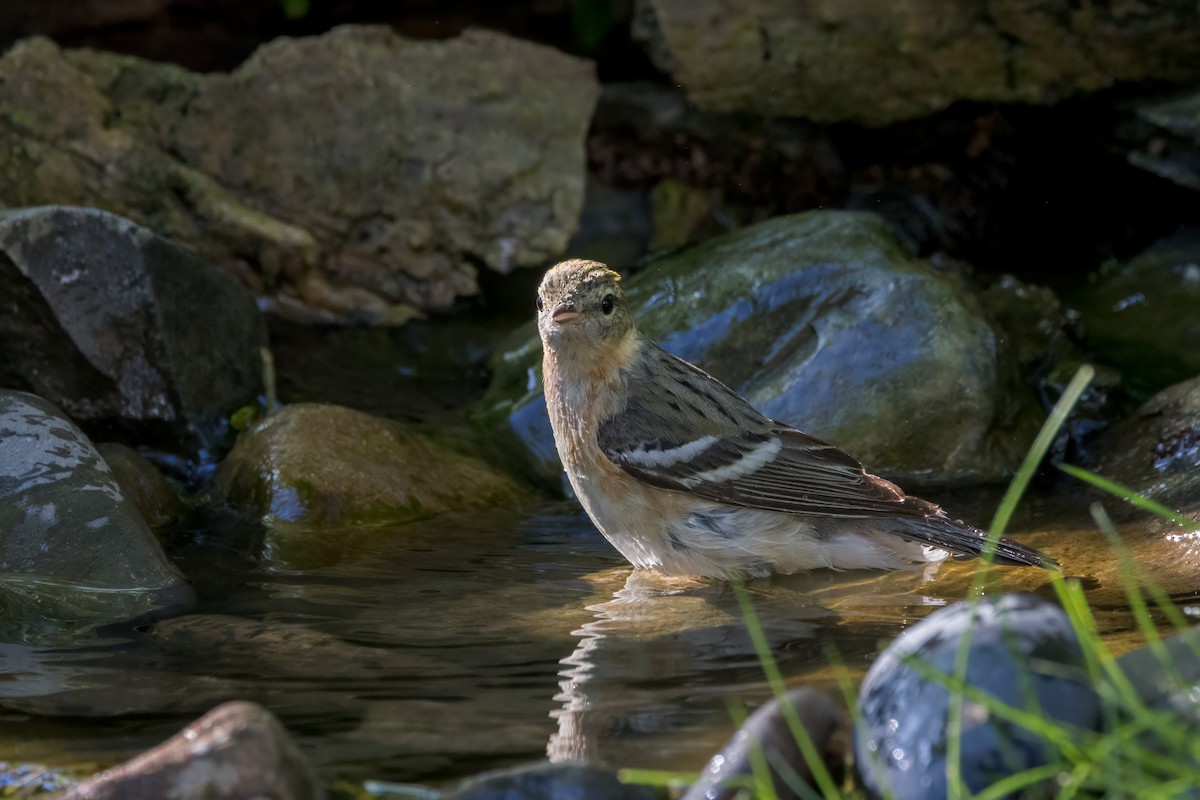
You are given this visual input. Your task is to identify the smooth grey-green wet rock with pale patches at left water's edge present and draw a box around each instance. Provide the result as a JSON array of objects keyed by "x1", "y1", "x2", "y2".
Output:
[{"x1": 0, "y1": 390, "x2": 192, "y2": 625}]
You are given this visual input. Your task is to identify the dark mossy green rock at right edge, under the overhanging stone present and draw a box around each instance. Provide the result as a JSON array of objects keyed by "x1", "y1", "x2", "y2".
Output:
[{"x1": 1072, "y1": 229, "x2": 1200, "y2": 396}]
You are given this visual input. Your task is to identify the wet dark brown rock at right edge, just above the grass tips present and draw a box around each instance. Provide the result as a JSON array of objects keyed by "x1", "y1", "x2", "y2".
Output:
[{"x1": 1091, "y1": 377, "x2": 1200, "y2": 522}]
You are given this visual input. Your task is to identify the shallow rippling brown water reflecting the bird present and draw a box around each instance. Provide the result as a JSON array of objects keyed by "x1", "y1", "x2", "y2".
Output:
[{"x1": 0, "y1": 482, "x2": 1195, "y2": 783}]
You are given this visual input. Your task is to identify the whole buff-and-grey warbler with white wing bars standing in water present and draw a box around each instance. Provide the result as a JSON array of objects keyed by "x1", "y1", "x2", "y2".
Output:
[{"x1": 536, "y1": 260, "x2": 1056, "y2": 578}]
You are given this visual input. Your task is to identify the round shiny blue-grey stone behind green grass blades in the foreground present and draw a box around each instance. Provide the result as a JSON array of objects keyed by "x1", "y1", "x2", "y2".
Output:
[{"x1": 854, "y1": 594, "x2": 1100, "y2": 800}]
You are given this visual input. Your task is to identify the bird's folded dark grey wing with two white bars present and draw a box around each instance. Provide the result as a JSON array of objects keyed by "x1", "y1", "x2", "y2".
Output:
[{"x1": 598, "y1": 348, "x2": 937, "y2": 518}]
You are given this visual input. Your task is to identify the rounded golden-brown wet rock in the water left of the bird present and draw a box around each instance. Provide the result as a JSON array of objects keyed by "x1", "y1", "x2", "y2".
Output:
[{"x1": 214, "y1": 403, "x2": 526, "y2": 524}]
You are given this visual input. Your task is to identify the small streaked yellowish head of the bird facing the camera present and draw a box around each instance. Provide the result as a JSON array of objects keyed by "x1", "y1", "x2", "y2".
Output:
[{"x1": 538, "y1": 259, "x2": 634, "y2": 360}]
